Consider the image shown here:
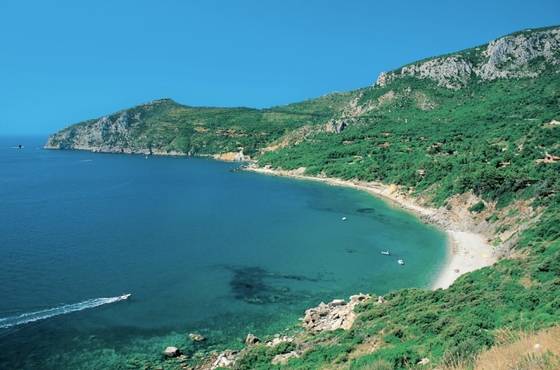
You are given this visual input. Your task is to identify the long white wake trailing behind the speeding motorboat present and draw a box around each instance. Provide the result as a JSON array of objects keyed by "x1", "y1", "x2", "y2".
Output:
[{"x1": 0, "y1": 294, "x2": 130, "y2": 329}]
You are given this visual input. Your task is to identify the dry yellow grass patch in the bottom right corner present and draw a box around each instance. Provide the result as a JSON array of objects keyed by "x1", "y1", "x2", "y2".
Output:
[{"x1": 446, "y1": 327, "x2": 560, "y2": 370}]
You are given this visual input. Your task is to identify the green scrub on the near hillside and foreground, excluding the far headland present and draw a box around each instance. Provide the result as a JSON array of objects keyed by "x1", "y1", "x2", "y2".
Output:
[{"x1": 232, "y1": 72, "x2": 560, "y2": 369}]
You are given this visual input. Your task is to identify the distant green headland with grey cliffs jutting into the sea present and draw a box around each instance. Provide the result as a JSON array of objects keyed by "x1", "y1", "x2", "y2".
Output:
[{"x1": 51, "y1": 93, "x2": 352, "y2": 156}]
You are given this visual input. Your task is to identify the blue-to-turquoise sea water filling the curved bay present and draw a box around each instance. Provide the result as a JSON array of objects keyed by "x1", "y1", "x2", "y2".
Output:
[{"x1": 0, "y1": 137, "x2": 446, "y2": 369}]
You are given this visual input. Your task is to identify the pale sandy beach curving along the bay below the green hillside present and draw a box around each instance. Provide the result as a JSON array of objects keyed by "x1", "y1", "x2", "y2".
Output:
[{"x1": 243, "y1": 164, "x2": 498, "y2": 290}]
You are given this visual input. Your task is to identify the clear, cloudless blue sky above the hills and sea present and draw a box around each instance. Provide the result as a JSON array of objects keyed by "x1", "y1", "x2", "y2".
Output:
[{"x1": 0, "y1": 0, "x2": 560, "y2": 134}]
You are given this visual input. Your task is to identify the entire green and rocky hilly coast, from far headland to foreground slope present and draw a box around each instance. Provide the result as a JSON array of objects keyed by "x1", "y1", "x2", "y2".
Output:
[{"x1": 46, "y1": 27, "x2": 560, "y2": 369}]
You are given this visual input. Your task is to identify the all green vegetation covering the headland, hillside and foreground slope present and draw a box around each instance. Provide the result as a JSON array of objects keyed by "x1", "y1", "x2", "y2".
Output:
[{"x1": 49, "y1": 25, "x2": 560, "y2": 369}]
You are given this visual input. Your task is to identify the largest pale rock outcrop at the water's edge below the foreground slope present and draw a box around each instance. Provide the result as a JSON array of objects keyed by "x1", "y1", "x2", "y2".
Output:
[{"x1": 303, "y1": 294, "x2": 371, "y2": 332}]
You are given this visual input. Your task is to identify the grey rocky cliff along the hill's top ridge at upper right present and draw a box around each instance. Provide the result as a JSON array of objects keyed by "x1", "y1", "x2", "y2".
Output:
[{"x1": 376, "y1": 27, "x2": 560, "y2": 89}]
